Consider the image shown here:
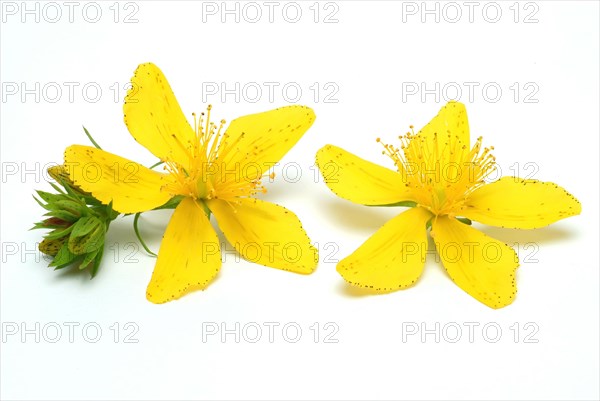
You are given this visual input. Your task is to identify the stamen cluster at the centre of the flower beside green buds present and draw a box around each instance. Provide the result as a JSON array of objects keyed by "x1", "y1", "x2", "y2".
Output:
[{"x1": 163, "y1": 105, "x2": 274, "y2": 203}]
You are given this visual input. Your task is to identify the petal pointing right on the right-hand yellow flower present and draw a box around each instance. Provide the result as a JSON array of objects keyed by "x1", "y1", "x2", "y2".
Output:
[{"x1": 459, "y1": 177, "x2": 581, "y2": 228}]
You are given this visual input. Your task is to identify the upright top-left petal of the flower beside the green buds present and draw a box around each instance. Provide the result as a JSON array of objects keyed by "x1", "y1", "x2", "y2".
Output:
[{"x1": 123, "y1": 63, "x2": 195, "y2": 163}]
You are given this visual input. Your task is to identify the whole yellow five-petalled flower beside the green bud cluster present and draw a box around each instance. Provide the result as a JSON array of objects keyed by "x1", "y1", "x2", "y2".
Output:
[{"x1": 65, "y1": 63, "x2": 318, "y2": 303}]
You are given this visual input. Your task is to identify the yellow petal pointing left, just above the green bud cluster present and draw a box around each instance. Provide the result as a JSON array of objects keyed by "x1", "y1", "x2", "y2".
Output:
[{"x1": 65, "y1": 145, "x2": 171, "y2": 213}]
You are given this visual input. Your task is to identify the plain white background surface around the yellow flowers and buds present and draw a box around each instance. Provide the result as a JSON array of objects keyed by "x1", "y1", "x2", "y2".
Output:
[{"x1": 0, "y1": 1, "x2": 600, "y2": 399}]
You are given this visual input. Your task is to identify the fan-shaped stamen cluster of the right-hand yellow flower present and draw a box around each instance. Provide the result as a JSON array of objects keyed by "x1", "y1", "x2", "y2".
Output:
[{"x1": 377, "y1": 126, "x2": 496, "y2": 215}]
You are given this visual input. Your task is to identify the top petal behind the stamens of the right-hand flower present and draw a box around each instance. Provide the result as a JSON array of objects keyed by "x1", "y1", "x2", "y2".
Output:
[{"x1": 409, "y1": 101, "x2": 470, "y2": 154}]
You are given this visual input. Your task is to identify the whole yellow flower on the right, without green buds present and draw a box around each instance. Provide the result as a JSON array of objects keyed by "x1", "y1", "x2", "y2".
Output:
[{"x1": 317, "y1": 102, "x2": 581, "y2": 308}]
